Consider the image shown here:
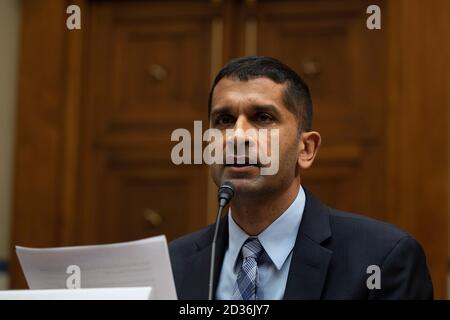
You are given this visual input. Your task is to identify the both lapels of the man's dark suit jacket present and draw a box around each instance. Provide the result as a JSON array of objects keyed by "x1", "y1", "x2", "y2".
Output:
[{"x1": 179, "y1": 189, "x2": 332, "y2": 300}]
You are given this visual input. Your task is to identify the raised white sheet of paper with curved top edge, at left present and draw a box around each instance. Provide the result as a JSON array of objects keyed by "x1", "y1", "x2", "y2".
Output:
[{"x1": 16, "y1": 236, "x2": 177, "y2": 300}]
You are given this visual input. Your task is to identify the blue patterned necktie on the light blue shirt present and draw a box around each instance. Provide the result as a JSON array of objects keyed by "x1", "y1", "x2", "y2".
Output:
[{"x1": 232, "y1": 238, "x2": 264, "y2": 300}]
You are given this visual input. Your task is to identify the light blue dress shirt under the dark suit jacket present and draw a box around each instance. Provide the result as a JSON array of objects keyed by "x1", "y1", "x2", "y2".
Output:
[{"x1": 216, "y1": 186, "x2": 306, "y2": 300}]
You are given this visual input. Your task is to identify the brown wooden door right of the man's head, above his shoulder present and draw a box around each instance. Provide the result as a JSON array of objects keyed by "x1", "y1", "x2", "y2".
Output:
[{"x1": 253, "y1": 1, "x2": 388, "y2": 226}]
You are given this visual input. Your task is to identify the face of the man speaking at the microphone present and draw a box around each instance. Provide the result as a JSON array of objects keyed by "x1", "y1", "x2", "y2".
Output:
[{"x1": 210, "y1": 77, "x2": 300, "y2": 196}]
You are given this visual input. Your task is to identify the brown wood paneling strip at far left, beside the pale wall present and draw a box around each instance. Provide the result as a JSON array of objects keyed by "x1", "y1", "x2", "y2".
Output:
[{"x1": 11, "y1": 0, "x2": 67, "y2": 287}]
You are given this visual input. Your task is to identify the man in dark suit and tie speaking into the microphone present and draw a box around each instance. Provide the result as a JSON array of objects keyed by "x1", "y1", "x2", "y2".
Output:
[{"x1": 169, "y1": 56, "x2": 433, "y2": 300}]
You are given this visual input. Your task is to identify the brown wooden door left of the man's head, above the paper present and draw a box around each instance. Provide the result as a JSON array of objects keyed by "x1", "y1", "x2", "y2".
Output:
[{"x1": 76, "y1": 1, "x2": 214, "y2": 243}]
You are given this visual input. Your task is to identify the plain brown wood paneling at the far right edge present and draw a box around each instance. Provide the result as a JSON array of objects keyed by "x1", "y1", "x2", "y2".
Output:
[{"x1": 385, "y1": 0, "x2": 450, "y2": 298}]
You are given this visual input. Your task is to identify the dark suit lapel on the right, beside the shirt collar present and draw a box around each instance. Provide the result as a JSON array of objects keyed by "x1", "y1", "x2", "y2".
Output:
[{"x1": 284, "y1": 189, "x2": 332, "y2": 300}]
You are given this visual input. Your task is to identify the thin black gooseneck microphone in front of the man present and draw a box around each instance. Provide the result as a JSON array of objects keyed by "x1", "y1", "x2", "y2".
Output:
[{"x1": 208, "y1": 181, "x2": 234, "y2": 300}]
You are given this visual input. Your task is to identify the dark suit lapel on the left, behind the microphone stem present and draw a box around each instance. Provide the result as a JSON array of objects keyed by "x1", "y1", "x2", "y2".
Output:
[{"x1": 180, "y1": 215, "x2": 228, "y2": 300}]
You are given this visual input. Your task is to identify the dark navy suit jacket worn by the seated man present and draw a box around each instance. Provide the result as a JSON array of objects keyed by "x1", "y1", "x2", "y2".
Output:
[{"x1": 169, "y1": 189, "x2": 433, "y2": 299}]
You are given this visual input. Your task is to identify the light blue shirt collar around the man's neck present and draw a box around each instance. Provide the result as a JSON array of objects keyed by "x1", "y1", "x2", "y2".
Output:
[{"x1": 228, "y1": 186, "x2": 306, "y2": 270}]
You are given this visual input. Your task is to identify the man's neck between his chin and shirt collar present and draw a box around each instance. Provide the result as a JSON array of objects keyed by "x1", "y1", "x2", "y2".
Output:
[{"x1": 231, "y1": 183, "x2": 300, "y2": 236}]
